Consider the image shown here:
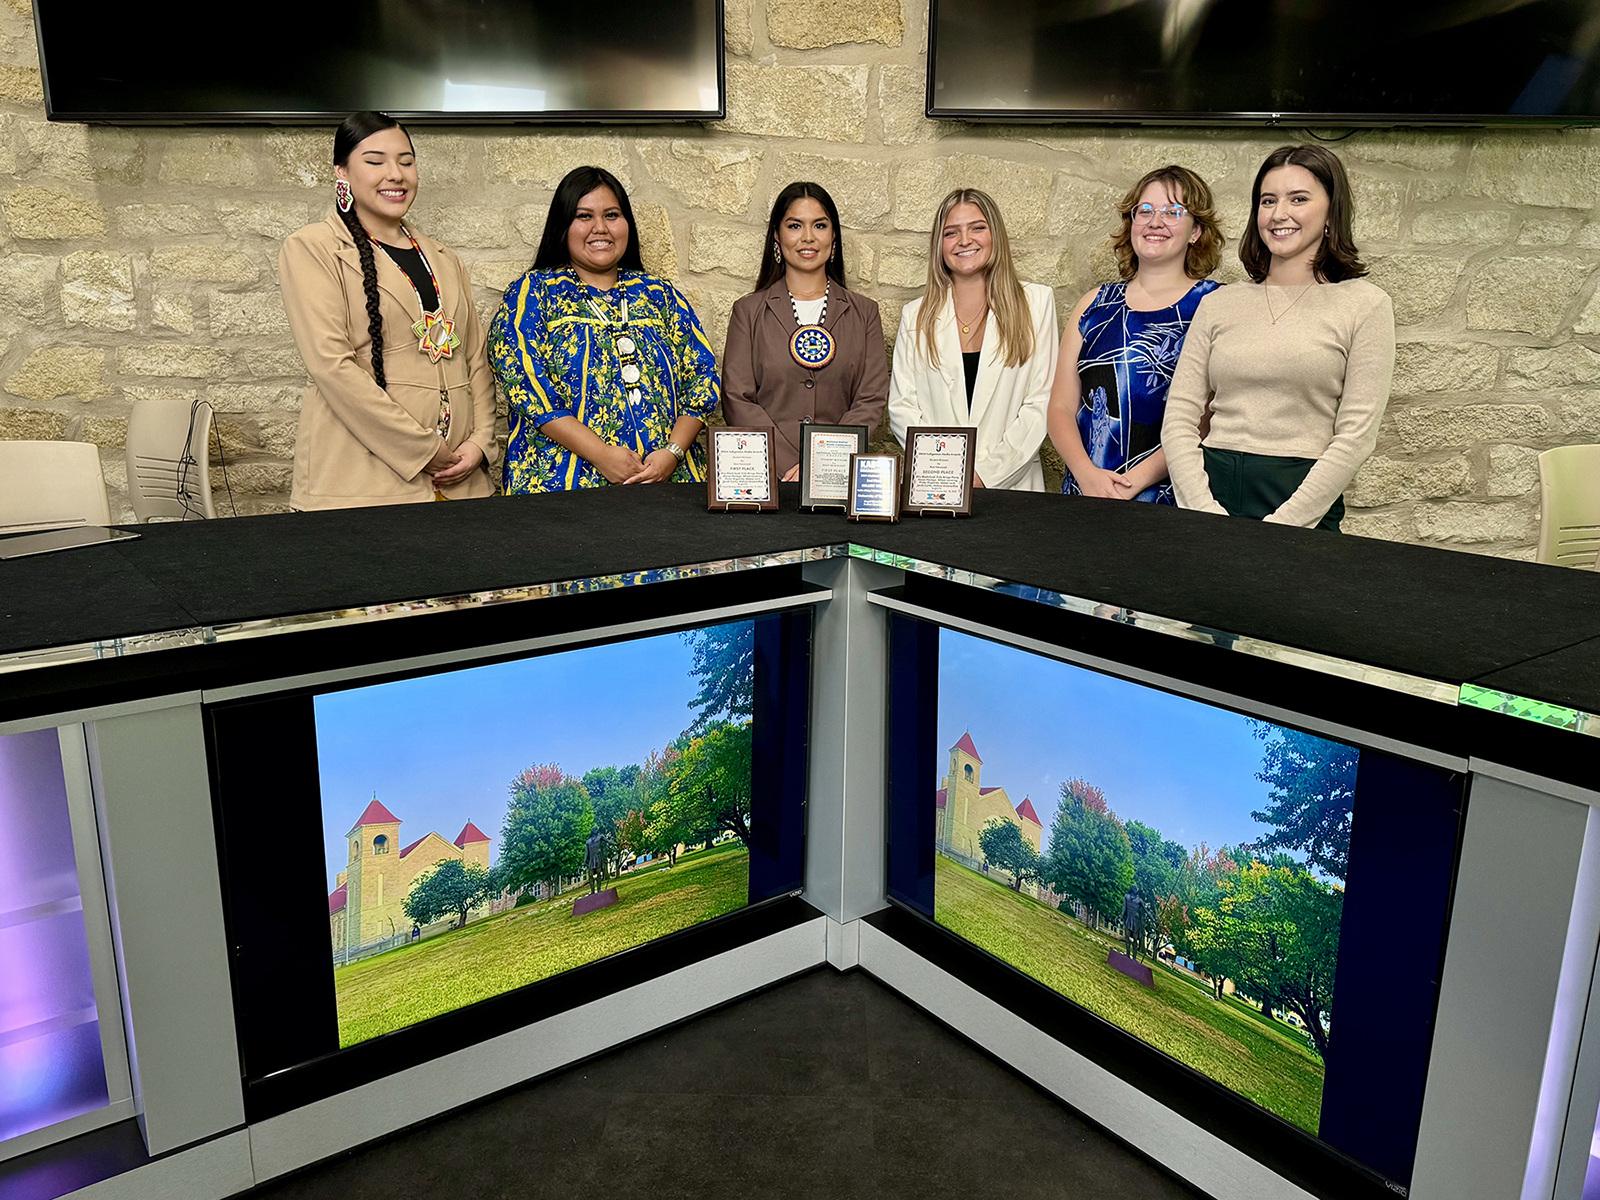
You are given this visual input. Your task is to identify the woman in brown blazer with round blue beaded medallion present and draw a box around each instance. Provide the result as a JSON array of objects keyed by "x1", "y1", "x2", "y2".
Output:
[{"x1": 722, "y1": 182, "x2": 890, "y2": 480}]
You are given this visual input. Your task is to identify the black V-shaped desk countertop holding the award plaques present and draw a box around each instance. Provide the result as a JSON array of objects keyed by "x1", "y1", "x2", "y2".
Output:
[{"x1": 0, "y1": 485, "x2": 1600, "y2": 714}]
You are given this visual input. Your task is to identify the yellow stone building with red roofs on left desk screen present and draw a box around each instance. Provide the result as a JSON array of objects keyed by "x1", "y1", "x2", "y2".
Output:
[{"x1": 328, "y1": 795, "x2": 490, "y2": 957}]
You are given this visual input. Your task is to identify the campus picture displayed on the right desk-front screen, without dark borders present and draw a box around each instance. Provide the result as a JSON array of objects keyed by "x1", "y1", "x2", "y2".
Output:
[{"x1": 933, "y1": 630, "x2": 1360, "y2": 1133}]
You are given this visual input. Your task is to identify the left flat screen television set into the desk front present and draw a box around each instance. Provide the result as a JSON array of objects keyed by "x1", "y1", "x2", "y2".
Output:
[{"x1": 208, "y1": 611, "x2": 810, "y2": 1115}]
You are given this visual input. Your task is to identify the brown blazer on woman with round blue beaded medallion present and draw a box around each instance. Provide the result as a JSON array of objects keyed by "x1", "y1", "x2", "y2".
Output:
[{"x1": 722, "y1": 278, "x2": 890, "y2": 475}]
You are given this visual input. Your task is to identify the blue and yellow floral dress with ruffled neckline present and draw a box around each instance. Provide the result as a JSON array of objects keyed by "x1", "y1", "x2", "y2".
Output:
[{"x1": 490, "y1": 267, "x2": 722, "y2": 493}]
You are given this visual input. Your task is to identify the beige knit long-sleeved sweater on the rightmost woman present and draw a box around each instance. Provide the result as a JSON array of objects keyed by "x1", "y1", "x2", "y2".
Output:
[{"x1": 1162, "y1": 278, "x2": 1395, "y2": 526}]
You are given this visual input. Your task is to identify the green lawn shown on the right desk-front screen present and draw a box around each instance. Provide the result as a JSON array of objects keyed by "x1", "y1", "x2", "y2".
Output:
[{"x1": 933, "y1": 854, "x2": 1323, "y2": 1133}]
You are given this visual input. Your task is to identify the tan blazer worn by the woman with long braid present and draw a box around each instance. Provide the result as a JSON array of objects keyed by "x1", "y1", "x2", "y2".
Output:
[{"x1": 278, "y1": 213, "x2": 499, "y2": 509}]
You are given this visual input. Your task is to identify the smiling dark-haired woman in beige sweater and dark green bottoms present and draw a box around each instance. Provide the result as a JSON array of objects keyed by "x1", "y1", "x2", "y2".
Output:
[{"x1": 1162, "y1": 146, "x2": 1395, "y2": 530}]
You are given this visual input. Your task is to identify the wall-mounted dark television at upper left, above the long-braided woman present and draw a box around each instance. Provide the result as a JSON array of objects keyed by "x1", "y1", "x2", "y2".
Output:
[{"x1": 34, "y1": 0, "x2": 725, "y2": 123}]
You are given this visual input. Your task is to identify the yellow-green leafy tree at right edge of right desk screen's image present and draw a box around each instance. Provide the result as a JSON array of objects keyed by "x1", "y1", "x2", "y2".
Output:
[{"x1": 1194, "y1": 862, "x2": 1344, "y2": 1061}]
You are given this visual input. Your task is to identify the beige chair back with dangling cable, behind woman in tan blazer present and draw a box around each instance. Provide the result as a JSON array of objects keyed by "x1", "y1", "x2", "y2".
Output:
[{"x1": 126, "y1": 400, "x2": 216, "y2": 525}]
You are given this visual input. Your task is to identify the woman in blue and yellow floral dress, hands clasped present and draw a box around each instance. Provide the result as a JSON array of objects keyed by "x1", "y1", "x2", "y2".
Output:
[{"x1": 490, "y1": 166, "x2": 720, "y2": 493}]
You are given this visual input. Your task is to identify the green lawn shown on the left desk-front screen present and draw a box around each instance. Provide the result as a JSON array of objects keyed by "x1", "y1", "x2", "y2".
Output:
[{"x1": 333, "y1": 842, "x2": 750, "y2": 1046}]
